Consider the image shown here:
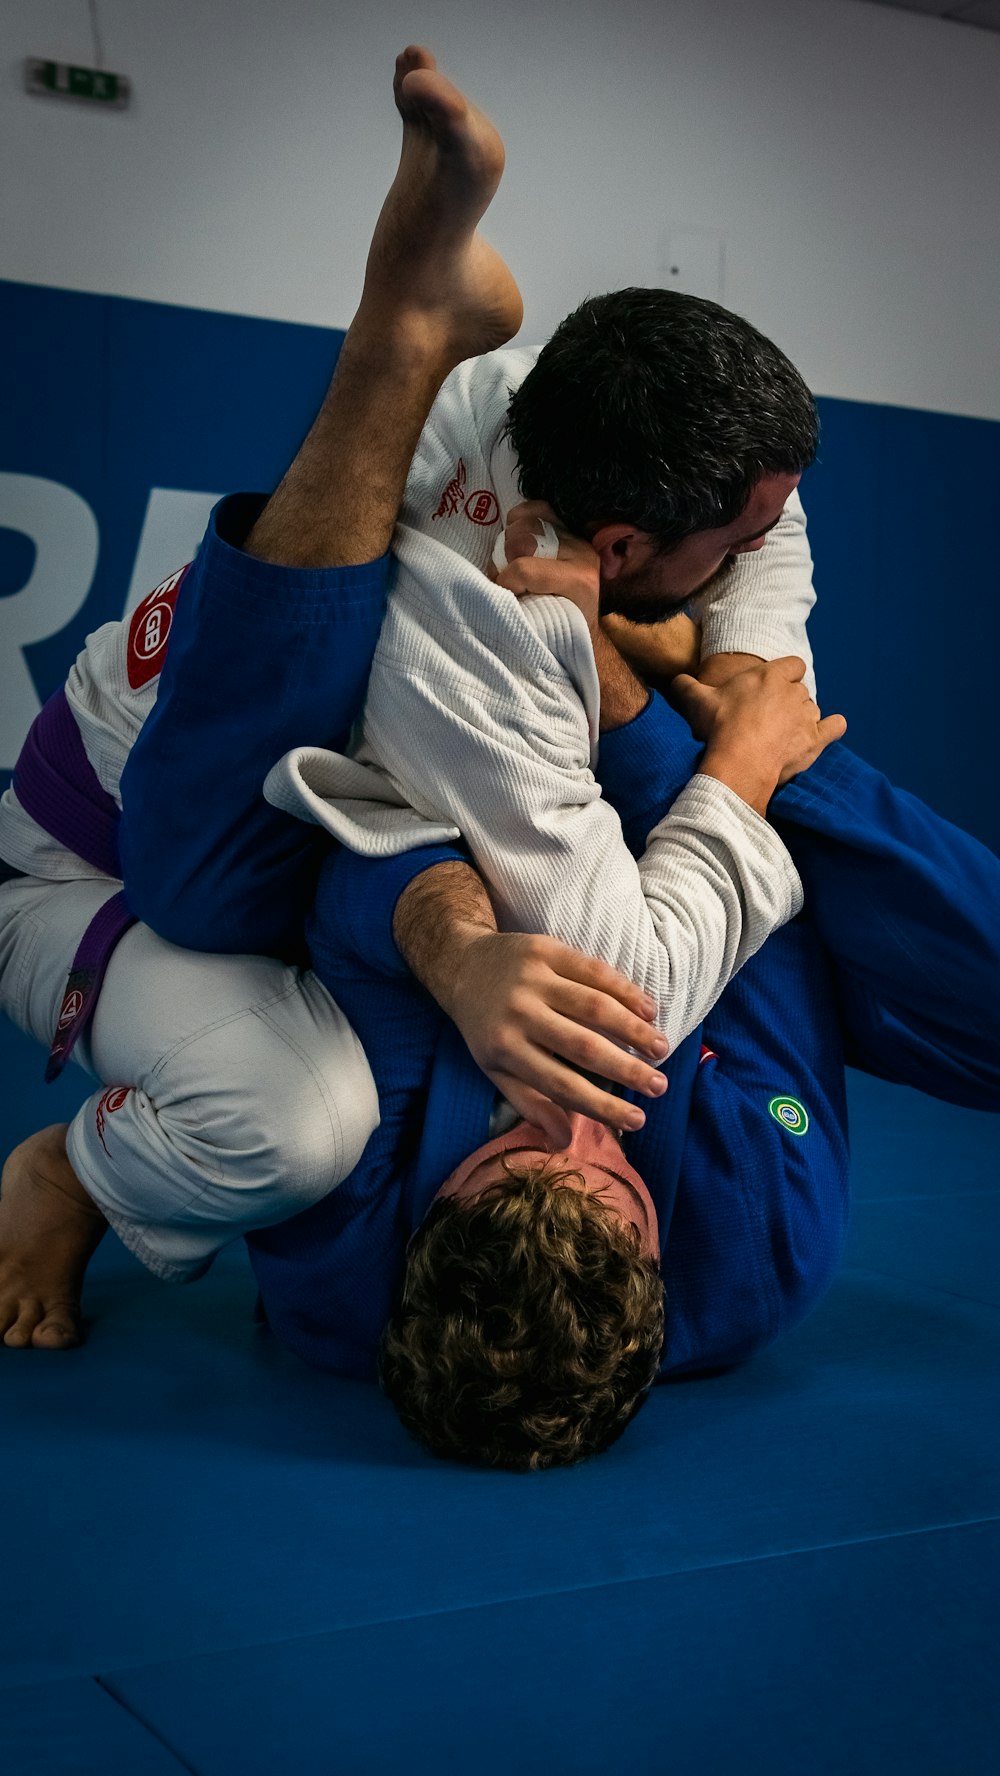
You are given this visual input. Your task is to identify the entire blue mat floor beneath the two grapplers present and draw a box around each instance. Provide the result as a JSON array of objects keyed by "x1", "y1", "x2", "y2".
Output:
[{"x1": 0, "y1": 1030, "x2": 1000, "y2": 1776}]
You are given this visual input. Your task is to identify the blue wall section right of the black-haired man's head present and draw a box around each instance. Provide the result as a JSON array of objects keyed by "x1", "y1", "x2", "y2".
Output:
[{"x1": 803, "y1": 400, "x2": 1000, "y2": 851}]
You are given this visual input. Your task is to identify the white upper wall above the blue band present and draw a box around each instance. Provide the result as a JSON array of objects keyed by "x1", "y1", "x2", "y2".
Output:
[{"x1": 0, "y1": 0, "x2": 1000, "y2": 419}]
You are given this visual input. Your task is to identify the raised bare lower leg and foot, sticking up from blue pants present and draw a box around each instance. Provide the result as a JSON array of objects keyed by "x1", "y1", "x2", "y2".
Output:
[{"x1": 245, "y1": 48, "x2": 522, "y2": 567}]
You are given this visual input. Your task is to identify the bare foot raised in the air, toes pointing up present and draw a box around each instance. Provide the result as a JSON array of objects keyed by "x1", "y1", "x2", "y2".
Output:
[{"x1": 355, "y1": 48, "x2": 522, "y2": 362}]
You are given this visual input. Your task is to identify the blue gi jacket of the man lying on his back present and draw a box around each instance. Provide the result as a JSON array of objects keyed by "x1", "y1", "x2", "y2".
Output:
[{"x1": 238, "y1": 816, "x2": 847, "y2": 1376}]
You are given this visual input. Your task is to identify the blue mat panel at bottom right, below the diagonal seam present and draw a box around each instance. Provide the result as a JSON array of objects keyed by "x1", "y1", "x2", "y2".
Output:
[{"x1": 108, "y1": 1524, "x2": 1000, "y2": 1776}]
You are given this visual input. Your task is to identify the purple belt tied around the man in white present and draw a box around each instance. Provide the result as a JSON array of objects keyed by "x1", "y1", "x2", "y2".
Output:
[{"x1": 14, "y1": 691, "x2": 135, "y2": 1080}]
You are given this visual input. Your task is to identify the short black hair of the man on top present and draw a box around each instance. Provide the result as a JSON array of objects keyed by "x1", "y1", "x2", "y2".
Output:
[{"x1": 506, "y1": 289, "x2": 819, "y2": 551}]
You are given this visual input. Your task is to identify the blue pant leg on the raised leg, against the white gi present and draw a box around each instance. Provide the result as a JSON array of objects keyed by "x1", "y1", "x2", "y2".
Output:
[{"x1": 121, "y1": 494, "x2": 389, "y2": 961}]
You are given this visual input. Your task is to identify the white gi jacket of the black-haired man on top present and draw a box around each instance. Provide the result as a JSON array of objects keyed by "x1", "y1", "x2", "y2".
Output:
[{"x1": 265, "y1": 350, "x2": 815, "y2": 1050}]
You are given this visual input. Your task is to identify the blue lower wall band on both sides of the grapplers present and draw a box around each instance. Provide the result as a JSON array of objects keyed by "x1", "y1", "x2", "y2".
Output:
[{"x1": 0, "y1": 282, "x2": 1000, "y2": 851}]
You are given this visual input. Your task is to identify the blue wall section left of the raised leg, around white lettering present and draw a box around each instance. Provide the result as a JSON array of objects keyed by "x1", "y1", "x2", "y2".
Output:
[{"x1": 0, "y1": 281, "x2": 343, "y2": 713}]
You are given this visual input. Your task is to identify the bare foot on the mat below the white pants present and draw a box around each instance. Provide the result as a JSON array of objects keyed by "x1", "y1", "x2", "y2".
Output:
[{"x1": 0, "y1": 1122, "x2": 108, "y2": 1350}]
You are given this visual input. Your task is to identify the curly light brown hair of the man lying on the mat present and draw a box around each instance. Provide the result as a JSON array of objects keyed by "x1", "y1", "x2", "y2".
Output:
[{"x1": 380, "y1": 1163, "x2": 663, "y2": 1471}]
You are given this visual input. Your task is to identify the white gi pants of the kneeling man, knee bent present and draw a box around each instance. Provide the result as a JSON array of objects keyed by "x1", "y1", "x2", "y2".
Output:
[{"x1": 0, "y1": 874, "x2": 378, "y2": 1282}]
